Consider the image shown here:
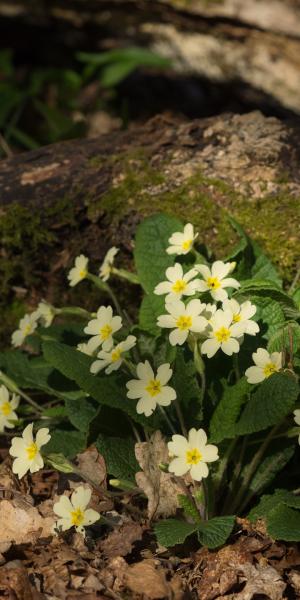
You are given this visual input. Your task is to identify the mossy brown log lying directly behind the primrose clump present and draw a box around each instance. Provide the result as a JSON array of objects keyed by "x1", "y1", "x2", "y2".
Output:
[{"x1": 0, "y1": 112, "x2": 300, "y2": 342}]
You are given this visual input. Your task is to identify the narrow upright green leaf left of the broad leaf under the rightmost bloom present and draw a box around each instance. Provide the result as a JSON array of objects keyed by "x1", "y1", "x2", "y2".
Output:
[{"x1": 210, "y1": 377, "x2": 251, "y2": 444}]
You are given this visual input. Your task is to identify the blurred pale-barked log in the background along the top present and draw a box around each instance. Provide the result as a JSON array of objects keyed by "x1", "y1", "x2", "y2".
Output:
[{"x1": 0, "y1": 0, "x2": 300, "y2": 113}]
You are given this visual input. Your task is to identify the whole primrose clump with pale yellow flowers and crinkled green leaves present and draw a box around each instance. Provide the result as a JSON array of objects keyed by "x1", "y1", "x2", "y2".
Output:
[{"x1": 0, "y1": 214, "x2": 300, "y2": 548}]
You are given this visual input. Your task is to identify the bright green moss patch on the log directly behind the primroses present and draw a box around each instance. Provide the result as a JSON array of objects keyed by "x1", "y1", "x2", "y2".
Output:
[{"x1": 89, "y1": 155, "x2": 299, "y2": 280}]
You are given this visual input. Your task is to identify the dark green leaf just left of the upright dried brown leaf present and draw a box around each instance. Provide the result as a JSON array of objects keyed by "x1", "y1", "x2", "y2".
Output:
[{"x1": 95, "y1": 435, "x2": 141, "y2": 481}]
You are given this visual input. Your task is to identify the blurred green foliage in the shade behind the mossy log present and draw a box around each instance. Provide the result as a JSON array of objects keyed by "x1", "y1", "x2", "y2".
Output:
[{"x1": 0, "y1": 47, "x2": 170, "y2": 156}]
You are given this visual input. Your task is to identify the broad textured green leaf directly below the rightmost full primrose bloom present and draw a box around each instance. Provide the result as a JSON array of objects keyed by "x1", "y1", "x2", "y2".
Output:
[{"x1": 236, "y1": 373, "x2": 299, "y2": 435}]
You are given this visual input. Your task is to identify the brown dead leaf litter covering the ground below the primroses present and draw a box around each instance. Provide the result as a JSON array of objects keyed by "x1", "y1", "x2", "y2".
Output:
[{"x1": 0, "y1": 442, "x2": 300, "y2": 600}]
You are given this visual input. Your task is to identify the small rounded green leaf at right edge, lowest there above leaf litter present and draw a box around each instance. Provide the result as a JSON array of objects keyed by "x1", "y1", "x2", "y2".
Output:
[{"x1": 267, "y1": 504, "x2": 300, "y2": 542}]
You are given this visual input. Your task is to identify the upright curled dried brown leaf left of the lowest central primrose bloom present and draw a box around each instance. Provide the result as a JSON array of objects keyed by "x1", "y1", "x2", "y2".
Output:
[{"x1": 135, "y1": 431, "x2": 182, "y2": 519}]
